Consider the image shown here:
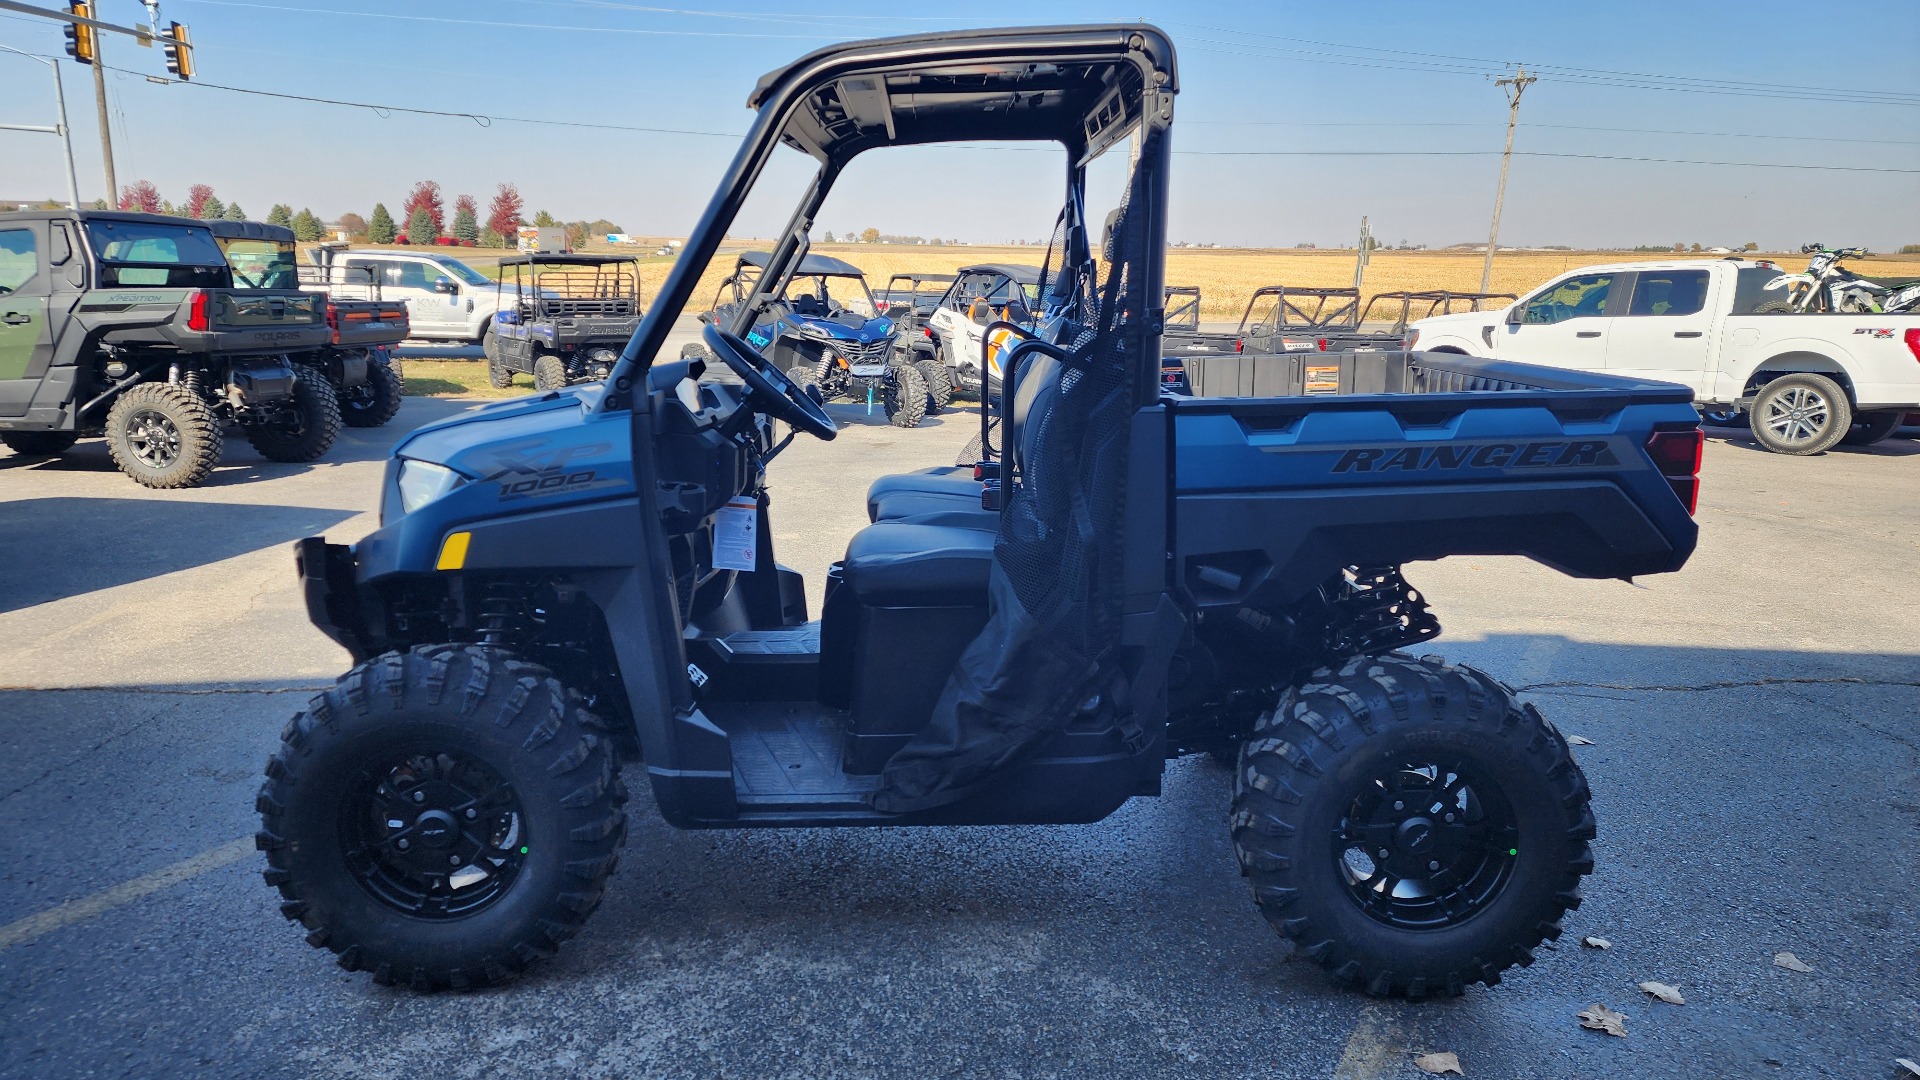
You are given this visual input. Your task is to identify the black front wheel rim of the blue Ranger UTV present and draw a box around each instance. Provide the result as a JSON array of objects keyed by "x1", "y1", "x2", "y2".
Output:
[{"x1": 340, "y1": 751, "x2": 528, "y2": 920}]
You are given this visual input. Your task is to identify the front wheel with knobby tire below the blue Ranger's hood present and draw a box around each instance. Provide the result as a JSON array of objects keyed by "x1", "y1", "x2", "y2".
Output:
[{"x1": 255, "y1": 644, "x2": 626, "y2": 990}]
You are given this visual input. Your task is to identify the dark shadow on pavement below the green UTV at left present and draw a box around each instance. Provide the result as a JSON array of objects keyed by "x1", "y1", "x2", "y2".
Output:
[{"x1": 0, "y1": 499, "x2": 355, "y2": 611}]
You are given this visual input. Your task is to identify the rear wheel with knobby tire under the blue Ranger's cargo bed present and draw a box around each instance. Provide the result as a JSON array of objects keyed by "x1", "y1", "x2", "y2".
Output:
[{"x1": 1231, "y1": 653, "x2": 1594, "y2": 997}]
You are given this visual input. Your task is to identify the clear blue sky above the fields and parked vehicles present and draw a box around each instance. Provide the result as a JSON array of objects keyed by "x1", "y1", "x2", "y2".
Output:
[{"x1": 0, "y1": 0, "x2": 1920, "y2": 250}]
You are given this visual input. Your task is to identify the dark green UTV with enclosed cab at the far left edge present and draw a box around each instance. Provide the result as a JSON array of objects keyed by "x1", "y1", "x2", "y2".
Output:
[{"x1": 0, "y1": 209, "x2": 340, "y2": 488}]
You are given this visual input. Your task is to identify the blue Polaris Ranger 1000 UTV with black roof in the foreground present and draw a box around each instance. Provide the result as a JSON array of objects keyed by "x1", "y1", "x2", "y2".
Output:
[{"x1": 257, "y1": 23, "x2": 1699, "y2": 997}]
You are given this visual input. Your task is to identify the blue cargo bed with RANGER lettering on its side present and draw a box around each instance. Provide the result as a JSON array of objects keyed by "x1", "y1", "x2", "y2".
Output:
[{"x1": 1164, "y1": 352, "x2": 1699, "y2": 605}]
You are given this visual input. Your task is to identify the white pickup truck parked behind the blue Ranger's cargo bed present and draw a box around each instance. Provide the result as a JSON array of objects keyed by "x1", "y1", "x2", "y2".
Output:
[{"x1": 1407, "y1": 259, "x2": 1920, "y2": 454}]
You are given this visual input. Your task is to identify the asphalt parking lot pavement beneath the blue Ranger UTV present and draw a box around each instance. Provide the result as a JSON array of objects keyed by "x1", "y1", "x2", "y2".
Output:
[{"x1": 0, "y1": 400, "x2": 1920, "y2": 1078}]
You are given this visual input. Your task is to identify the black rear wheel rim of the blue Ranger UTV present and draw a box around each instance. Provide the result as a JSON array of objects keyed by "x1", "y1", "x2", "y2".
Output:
[{"x1": 1332, "y1": 757, "x2": 1521, "y2": 930}]
